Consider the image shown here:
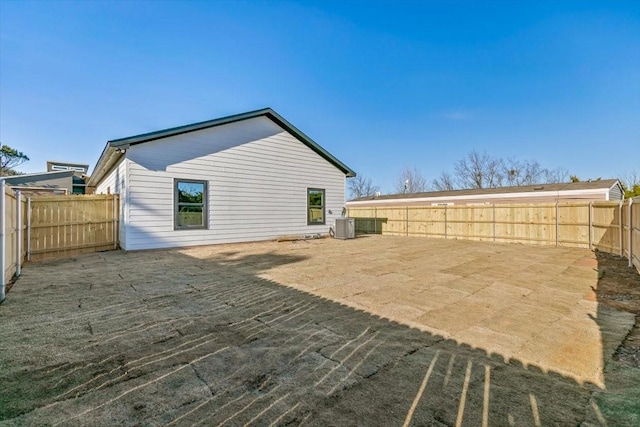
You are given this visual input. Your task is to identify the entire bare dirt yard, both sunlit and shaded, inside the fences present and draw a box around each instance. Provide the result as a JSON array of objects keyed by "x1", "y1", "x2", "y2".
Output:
[{"x1": 0, "y1": 236, "x2": 640, "y2": 426}]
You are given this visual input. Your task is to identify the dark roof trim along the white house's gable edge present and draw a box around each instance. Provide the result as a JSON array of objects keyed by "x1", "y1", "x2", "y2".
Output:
[{"x1": 108, "y1": 108, "x2": 356, "y2": 177}]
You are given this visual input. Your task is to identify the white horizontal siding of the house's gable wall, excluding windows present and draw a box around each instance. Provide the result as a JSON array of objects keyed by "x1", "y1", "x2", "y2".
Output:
[{"x1": 126, "y1": 117, "x2": 345, "y2": 250}]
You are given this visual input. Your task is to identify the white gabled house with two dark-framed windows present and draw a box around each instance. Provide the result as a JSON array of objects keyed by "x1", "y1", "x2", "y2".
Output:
[{"x1": 88, "y1": 108, "x2": 355, "y2": 250}]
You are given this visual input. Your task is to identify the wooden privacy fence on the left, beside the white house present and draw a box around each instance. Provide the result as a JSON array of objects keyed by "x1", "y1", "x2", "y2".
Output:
[{"x1": 0, "y1": 184, "x2": 119, "y2": 301}]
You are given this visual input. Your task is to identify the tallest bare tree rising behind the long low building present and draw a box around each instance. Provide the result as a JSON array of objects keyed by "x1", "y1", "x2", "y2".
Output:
[{"x1": 455, "y1": 150, "x2": 503, "y2": 188}]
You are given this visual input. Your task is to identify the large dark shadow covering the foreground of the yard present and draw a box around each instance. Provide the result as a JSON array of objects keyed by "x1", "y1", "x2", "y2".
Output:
[{"x1": 0, "y1": 244, "x2": 637, "y2": 426}]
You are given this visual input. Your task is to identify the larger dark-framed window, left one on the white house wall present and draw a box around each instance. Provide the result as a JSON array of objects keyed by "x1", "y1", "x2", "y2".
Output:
[{"x1": 174, "y1": 179, "x2": 208, "y2": 230}]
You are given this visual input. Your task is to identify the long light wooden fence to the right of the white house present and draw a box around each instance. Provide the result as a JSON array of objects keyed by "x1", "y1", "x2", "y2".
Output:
[{"x1": 348, "y1": 198, "x2": 640, "y2": 271}]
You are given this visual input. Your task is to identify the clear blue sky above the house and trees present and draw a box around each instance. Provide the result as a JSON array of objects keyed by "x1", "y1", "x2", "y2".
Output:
[{"x1": 0, "y1": 0, "x2": 640, "y2": 192}]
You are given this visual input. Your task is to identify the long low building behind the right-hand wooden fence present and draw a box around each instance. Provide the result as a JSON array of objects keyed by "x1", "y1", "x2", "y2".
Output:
[{"x1": 347, "y1": 179, "x2": 624, "y2": 207}]
